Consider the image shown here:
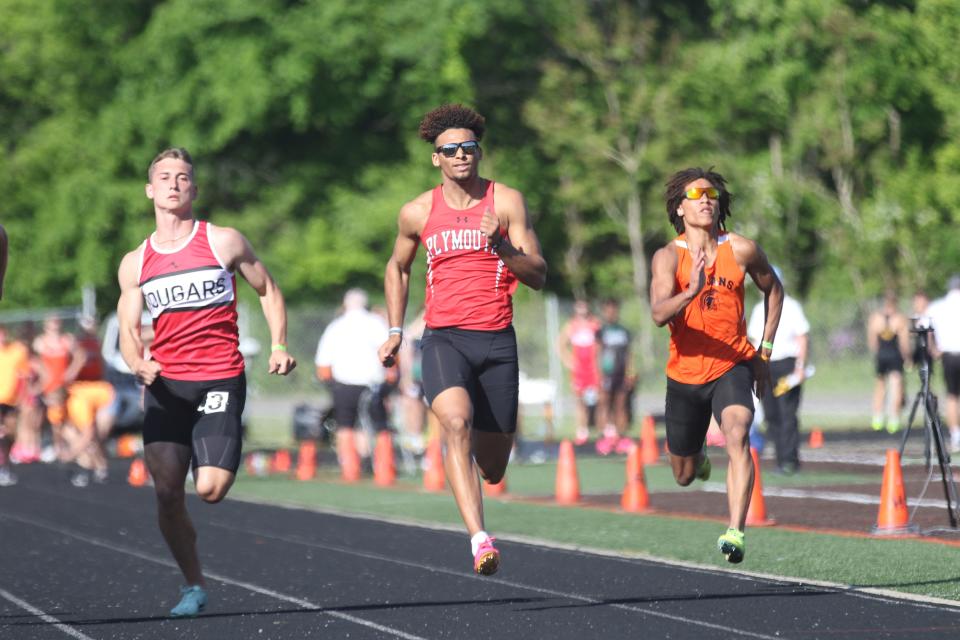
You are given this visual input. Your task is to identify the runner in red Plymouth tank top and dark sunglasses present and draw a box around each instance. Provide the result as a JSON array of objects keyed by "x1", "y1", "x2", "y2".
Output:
[{"x1": 379, "y1": 104, "x2": 547, "y2": 575}]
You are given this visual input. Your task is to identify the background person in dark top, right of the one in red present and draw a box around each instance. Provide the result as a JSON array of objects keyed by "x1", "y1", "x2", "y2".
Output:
[{"x1": 597, "y1": 298, "x2": 636, "y2": 455}]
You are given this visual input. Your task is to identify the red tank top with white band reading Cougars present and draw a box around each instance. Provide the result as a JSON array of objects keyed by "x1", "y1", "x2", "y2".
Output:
[{"x1": 139, "y1": 221, "x2": 243, "y2": 380}]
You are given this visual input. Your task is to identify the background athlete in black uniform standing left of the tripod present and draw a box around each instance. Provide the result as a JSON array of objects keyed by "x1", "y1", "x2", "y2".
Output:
[{"x1": 867, "y1": 291, "x2": 910, "y2": 433}]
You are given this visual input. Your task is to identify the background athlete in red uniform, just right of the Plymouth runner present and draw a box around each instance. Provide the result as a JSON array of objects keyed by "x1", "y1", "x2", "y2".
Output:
[{"x1": 557, "y1": 300, "x2": 600, "y2": 445}]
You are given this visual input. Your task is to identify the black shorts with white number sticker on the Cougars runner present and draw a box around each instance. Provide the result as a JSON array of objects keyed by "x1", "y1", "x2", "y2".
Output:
[{"x1": 143, "y1": 373, "x2": 247, "y2": 473}]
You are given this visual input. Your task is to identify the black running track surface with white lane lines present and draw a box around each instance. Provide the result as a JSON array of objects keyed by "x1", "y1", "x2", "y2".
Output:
[{"x1": 0, "y1": 465, "x2": 960, "y2": 640}]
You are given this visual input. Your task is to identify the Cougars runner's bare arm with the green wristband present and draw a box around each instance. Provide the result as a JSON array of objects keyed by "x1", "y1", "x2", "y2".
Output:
[{"x1": 207, "y1": 225, "x2": 297, "y2": 376}]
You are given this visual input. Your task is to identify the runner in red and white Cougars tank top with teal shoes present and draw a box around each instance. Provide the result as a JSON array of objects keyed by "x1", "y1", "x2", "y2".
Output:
[{"x1": 117, "y1": 148, "x2": 296, "y2": 617}]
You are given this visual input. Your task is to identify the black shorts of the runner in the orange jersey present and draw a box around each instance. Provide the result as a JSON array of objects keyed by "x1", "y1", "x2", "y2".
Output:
[{"x1": 665, "y1": 361, "x2": 754, "y2": 456}]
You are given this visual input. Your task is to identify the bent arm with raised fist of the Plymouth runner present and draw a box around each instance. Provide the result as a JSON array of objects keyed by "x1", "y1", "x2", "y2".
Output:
[{"x1": 488, "y1": 182, "x2": 547, "y2": 291}]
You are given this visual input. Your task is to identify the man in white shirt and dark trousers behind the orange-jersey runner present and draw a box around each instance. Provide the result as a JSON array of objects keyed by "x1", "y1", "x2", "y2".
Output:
[{"x1": 747, "y1": 267, "x2": 810, "y2": 475}]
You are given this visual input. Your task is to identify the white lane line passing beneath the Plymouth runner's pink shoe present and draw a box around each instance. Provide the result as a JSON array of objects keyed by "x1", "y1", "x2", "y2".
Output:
[{"x1": 207, "y1": 522, "x2": 783, "y2": 640}]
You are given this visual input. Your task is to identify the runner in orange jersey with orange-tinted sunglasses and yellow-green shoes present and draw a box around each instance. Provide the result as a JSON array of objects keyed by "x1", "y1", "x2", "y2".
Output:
[{"x1": 650, "y1": 168, "x2": 783, "y2": 563}]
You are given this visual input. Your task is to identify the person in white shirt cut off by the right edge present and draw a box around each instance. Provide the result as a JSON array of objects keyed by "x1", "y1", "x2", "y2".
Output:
[{"x1": 930, "y1": 274, "x2": 960, "y2": 453}]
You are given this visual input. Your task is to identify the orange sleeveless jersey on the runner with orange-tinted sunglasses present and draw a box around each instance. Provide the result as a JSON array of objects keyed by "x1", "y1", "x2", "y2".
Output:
[{"x1": 667, "y1": 233, "x2": 755, "y2": 384}]
